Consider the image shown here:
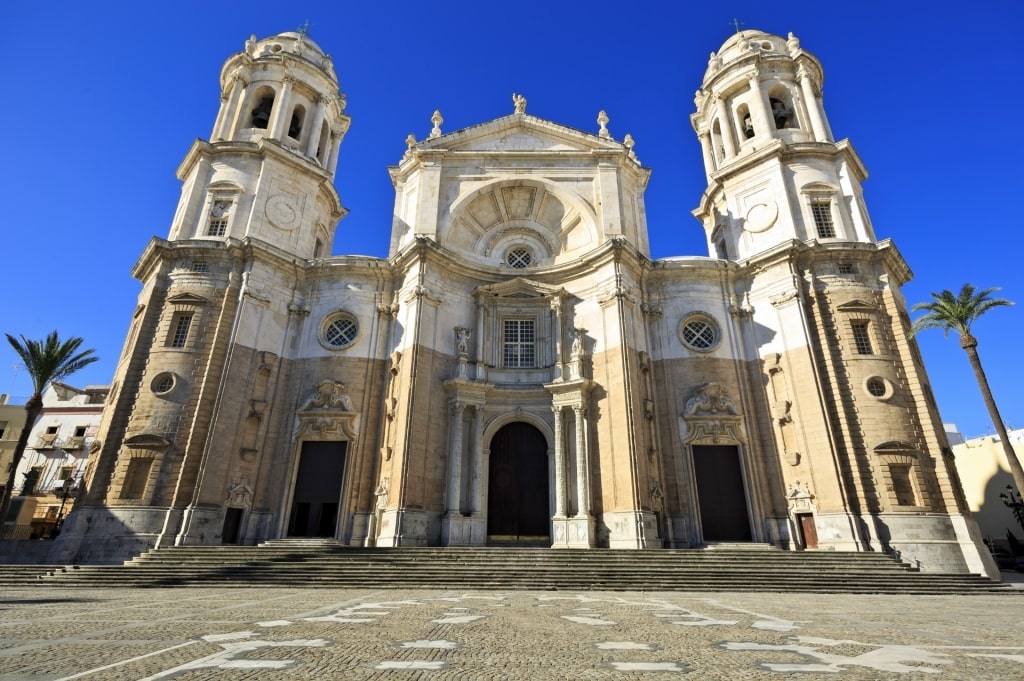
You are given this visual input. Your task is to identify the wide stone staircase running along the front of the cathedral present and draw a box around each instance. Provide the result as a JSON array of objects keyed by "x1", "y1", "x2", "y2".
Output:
[{"x1": 0, "y1": 540, "x2": 1011, "y2": 594}]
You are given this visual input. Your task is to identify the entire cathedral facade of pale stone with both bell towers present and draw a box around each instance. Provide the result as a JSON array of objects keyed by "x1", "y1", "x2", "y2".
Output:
[{"x1": 56, "y1": 31, "x2": 992, "y2": 573}]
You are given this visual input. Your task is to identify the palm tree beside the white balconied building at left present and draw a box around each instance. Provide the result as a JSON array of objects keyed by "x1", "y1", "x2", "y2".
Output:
[{"x1": 0, "y1": 331, "x2": 99, "y2": 519}]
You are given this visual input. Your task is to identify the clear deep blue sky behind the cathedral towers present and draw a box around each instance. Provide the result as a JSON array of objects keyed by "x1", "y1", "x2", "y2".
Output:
[{"x1": 0, "y1": 0, "x2": 1024, "y2": 436}]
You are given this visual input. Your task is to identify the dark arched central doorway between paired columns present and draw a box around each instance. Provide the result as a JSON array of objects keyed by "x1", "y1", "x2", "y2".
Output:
[{"x1": 487, "y1": 421, "x2": 551, "y2": 544}]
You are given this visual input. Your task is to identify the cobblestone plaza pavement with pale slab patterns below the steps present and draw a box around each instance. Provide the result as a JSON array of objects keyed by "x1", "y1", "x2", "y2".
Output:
[{"x1": 0, "y1": 588, "x2": 1024, "y2": 681}]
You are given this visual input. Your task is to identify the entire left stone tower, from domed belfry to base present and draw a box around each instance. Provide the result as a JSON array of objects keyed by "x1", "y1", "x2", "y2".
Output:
[{"x1": 63, "y1": 33, "x2": 349, "y2": 558}]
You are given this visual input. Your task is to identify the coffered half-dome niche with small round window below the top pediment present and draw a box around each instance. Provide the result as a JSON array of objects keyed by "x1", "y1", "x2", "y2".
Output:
[{"x1": 439, "y1": 179, "x2": 598, "y2": 267}]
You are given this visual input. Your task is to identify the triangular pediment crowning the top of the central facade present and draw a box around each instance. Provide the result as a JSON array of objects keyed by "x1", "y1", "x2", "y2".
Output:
[{"x1": 419, "y1": 114, "x2": 622, "y2": 153}]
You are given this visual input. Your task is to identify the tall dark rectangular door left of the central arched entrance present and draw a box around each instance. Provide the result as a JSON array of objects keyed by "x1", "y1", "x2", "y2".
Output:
[{"x1": 288, "y1": 442, "x2": 348, "y2": 537}]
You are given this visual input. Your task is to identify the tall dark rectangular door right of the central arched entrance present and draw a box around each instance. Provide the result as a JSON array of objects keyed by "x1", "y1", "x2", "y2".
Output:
[{"x1": 693, "y1": 444, "x2": 751, "y2": 542}]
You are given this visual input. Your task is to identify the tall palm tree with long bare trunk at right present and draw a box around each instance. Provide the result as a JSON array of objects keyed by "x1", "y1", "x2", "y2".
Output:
[{"x1": 911, "y1": 284, "x2": 1024, "y2": 497}]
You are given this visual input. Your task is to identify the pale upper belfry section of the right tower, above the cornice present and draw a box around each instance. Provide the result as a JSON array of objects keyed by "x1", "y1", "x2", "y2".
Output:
[{"x1": 690, "y1": 31, "x2": 874, "y2": 260}]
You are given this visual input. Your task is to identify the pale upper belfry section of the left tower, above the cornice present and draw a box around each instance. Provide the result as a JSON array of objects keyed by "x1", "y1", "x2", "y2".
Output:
[{"x1": 164, "y1": 33, "x2": 349, "y2": 258}]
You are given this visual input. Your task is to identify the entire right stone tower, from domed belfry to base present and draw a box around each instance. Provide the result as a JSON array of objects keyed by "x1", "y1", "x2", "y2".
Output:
[{"x1": 690, "y1": 31, "x2": 982, "y2": 570}]
